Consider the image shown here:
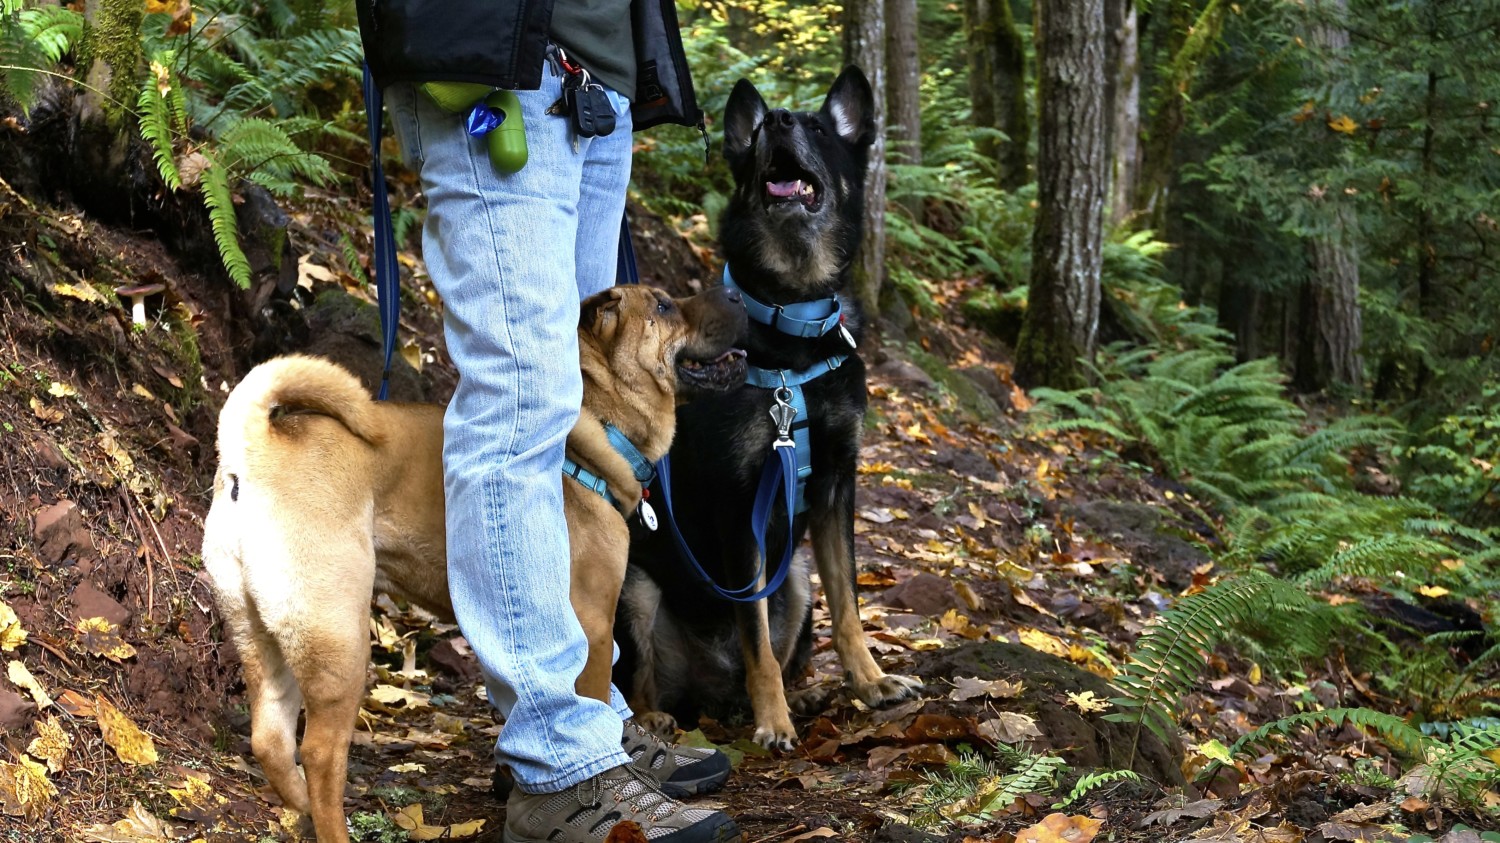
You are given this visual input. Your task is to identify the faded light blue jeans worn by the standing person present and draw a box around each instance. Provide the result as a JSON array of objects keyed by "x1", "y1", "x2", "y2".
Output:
[{"x1": 386, "y1": 69, "x2": 632, "y2": 794}]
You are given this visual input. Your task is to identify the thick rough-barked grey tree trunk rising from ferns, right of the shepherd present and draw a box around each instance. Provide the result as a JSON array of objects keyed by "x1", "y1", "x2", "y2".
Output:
[{"x1": 1016, "y1": 0, "x2": 1107, "y2": 389}]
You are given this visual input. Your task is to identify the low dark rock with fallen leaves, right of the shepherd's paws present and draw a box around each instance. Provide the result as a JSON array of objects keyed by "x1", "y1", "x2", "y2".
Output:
[{"x1": 915, "y1": 641, "x2": 1184, "y2": 785}]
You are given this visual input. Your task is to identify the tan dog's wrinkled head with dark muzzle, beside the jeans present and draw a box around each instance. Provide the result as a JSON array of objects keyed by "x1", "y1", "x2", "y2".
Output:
[{"x1": 579, "y1": 285, "x2": 749, "y2": 402}]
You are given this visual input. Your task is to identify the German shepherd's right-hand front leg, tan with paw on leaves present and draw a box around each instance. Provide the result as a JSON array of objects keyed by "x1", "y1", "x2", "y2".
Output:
[{"x1": 810, "y1": 501, "x2": 923, "y2": 707}]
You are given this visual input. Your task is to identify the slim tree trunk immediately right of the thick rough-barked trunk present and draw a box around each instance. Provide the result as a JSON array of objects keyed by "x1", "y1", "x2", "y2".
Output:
[{"x1": 1106, "y1": 0, "x2": 1140, "y2": 225}]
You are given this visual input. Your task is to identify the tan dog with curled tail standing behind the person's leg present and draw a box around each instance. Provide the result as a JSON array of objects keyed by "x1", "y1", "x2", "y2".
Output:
[{"x1": 203, "y1": 287, "x2": 746, "y2": 843}]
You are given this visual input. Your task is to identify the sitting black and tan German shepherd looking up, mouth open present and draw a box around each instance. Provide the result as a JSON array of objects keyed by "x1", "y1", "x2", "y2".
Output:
[{"x1": 615, "y1": 68, "x2": 920, "y2": 750}]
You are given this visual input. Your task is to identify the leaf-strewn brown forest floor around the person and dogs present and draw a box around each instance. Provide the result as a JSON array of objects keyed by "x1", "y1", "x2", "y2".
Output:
[{"x1": 0, "y1": 172, "x2": 1493, "y2": 843}]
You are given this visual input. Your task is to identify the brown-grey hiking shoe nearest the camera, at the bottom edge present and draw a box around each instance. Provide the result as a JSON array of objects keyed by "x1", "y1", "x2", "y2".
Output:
[{"x1": 501, "y1": 764, "x2": 741, "y2": 843}]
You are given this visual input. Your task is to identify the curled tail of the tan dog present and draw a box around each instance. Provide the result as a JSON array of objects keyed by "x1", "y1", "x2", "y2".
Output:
[{"x1": 219, "y1": 354, "x2": 383, "y2": 450}]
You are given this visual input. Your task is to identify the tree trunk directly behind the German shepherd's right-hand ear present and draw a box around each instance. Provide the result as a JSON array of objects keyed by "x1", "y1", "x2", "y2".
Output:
[{"x1": 845, "y1": 0, "x2": 885, "y2": 314}]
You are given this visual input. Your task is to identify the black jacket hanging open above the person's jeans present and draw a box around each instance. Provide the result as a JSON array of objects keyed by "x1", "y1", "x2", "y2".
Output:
[{"x1": 357, "y1": 0, "x2": 704, "y2": 129}]
